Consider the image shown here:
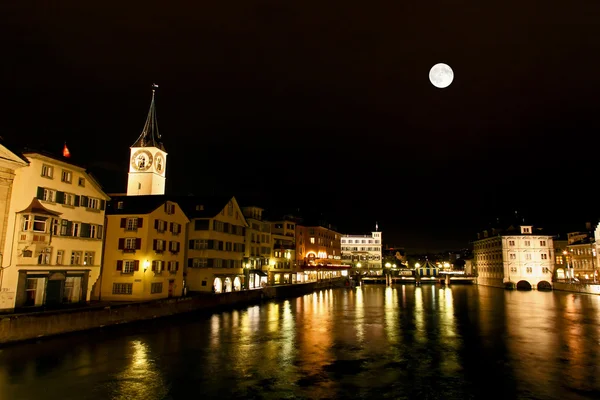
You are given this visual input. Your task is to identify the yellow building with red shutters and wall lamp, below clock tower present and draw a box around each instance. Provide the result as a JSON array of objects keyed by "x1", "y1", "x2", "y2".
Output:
[{"x1": 100, "y1": 195, "x2": 189, "y2": 301}]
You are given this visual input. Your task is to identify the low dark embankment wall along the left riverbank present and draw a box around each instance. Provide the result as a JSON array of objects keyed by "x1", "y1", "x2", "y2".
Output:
[{"x1": 0, "y1": 279, "x2": 345, "y2": 345}]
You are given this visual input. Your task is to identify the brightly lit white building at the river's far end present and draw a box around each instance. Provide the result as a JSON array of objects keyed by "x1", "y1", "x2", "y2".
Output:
[{"x1": 341, "y1": 230, "x2": 382, "y2": 275}]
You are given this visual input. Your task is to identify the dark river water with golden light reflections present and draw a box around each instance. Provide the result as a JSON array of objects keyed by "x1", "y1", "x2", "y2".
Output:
[{"x1": 0, "y1": 285, "x2": 600, "y2": 400}]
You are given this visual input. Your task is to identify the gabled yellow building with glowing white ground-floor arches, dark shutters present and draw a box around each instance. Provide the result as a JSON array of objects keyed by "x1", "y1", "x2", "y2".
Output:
[{"x1": 180, "y1": 196, "x2": 248, "y2": 293}]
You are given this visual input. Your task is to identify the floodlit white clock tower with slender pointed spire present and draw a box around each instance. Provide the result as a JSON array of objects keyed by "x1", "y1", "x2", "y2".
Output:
[{"x1": 127, "y1": 85, "x2": 167, "y2": 196}]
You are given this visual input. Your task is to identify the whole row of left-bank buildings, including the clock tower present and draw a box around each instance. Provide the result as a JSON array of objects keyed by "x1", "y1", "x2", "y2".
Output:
[{"x1": 0, "y1": 92, "x2": 351, "y2": 311}]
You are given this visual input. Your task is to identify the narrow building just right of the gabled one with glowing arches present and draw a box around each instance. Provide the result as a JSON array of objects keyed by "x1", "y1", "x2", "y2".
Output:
[{"x1": 242, "y1": 206, "x2": 273, "y2": 289}]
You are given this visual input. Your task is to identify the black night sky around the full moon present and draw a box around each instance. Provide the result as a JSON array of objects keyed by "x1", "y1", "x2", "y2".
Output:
[{"x1": 0, "y1": 0, "x2": 600, "y2": 250}]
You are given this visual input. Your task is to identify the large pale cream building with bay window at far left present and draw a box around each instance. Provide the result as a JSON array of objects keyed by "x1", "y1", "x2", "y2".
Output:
[{"x1": 0, "y1": 151, "x2": 109, "y2": 310}]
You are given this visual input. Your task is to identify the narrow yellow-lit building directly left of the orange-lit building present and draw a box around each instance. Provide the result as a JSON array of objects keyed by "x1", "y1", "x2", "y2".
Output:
[{"x1": 269, "y1": 216, "x2": 296, "y2": 285}]
